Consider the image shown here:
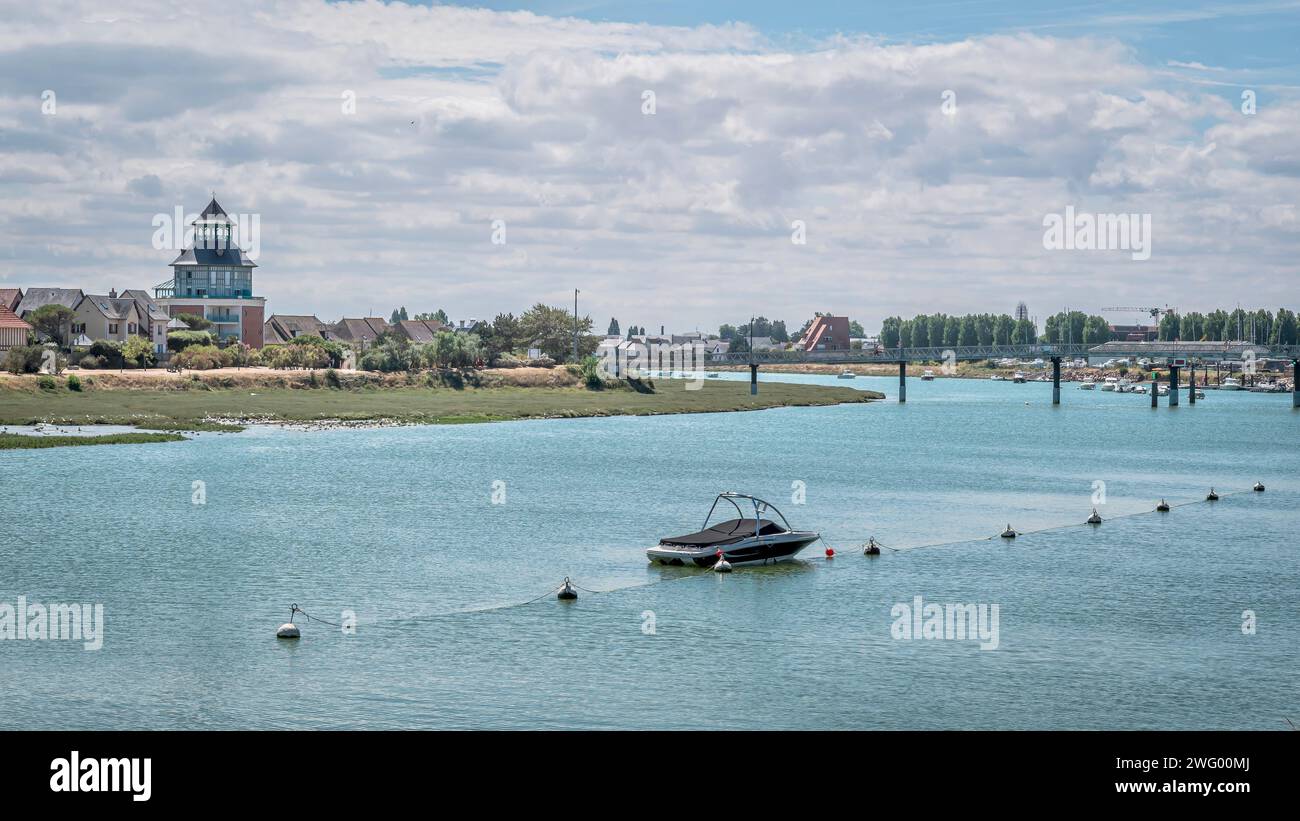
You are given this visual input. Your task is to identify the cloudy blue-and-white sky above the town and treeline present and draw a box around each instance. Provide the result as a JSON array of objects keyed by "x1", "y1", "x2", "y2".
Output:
[{"x1": 0, "y1": 0, "x2": 1300, "y2": 331}]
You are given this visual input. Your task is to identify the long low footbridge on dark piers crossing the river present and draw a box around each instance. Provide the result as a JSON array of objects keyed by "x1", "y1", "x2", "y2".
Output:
[{"x1": 706, "y1": 342, "x2": 1300, "y2": 408}]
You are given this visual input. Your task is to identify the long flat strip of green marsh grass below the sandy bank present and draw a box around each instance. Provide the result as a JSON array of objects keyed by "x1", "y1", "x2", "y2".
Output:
[{"x1": 0, "y1": 379, "x2": 880, "y2": 430}]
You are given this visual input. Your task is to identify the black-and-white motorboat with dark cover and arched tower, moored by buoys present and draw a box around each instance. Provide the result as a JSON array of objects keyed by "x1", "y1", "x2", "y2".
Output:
[{"x1": 646, "y1": 491, "x2": 820, "y2": 568}]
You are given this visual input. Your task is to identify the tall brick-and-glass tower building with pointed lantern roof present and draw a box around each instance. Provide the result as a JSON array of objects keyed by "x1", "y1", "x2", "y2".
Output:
[{"x1": 153, "y1": 197, "x2": 267, "y2": 348}]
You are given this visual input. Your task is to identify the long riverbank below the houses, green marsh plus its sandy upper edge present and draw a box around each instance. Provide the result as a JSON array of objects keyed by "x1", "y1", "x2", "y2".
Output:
[{"x1": 0, "y1": 368, "x2": 883, "y2": 430}]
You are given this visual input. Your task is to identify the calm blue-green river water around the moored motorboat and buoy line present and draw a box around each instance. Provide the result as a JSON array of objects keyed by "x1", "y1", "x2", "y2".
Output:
[{"x1": 0, "y1": 377, "x2": 1300, "y2": 729}]
